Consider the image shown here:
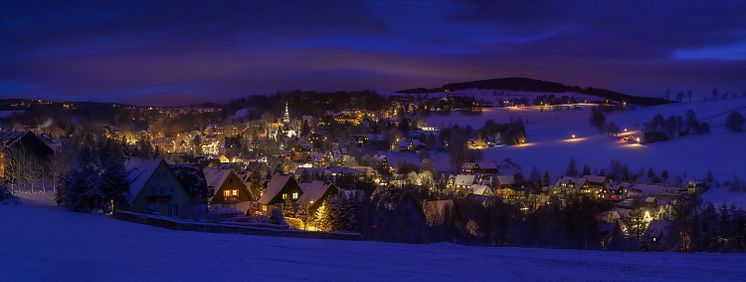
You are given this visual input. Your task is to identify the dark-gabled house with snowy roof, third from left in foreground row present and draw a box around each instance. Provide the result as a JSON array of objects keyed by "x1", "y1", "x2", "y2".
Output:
[{"x1": 257, "y1": 173, "x2": 303, "y2": 214}]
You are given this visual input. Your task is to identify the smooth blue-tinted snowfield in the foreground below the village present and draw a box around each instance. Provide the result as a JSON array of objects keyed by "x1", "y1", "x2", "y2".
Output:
[{"x1": 0, "y1": 196, "x2": 746, "y2": 281}]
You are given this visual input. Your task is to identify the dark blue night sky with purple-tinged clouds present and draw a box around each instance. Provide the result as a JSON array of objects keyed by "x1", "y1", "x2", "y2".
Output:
[{"x1": 0, "y1": 0, "x2": 746, "y2": 104}]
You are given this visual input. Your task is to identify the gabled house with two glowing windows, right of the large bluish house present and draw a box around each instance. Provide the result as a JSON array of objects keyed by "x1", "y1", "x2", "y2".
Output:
[{"x1": 202, "y1": 167, "x2": 251, "y2": 209}]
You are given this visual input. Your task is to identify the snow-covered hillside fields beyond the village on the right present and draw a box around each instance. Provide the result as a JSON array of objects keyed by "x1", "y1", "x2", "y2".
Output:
[{"x1": 389, "y1": 98, "x2": 746, "y2": 207}]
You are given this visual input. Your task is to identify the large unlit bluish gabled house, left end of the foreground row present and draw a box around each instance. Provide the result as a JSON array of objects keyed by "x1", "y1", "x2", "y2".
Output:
[{"x1": 125, "y1": 158, "x2": 192, "y2": 217}]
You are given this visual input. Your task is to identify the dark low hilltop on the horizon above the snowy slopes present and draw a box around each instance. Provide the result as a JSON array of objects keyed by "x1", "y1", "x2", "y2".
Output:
[{"x1": 398, "y1": 77, "x2": 672, "y2": 106}]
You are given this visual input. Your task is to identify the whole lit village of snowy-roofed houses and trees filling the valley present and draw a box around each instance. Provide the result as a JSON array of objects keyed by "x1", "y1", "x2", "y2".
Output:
[{"x1": 0, "y1": 90, "x2": 728, "y2": 250}]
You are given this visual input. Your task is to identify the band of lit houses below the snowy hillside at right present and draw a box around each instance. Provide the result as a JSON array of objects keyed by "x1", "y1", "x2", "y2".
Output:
[{"x1": 448, "y1": 161, "x2": 692, "y2": 243}]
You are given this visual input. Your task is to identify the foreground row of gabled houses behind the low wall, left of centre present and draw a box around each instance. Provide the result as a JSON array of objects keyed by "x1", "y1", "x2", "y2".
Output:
[{"x1": 125, "y1": 158, "x2": 337, "y2": 227}]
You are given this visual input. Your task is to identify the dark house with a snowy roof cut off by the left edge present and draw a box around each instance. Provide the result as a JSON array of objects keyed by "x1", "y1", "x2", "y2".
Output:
[{"x1": 0, "y1": 130, "x2": 54, "y2": 177}]
